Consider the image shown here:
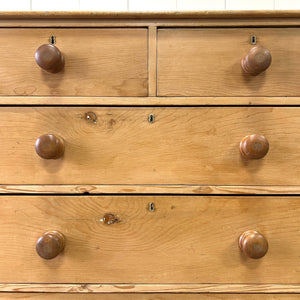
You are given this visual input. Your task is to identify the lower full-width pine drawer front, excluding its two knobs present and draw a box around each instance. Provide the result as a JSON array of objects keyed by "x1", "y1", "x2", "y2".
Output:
[{"x1": 0, "y1": 196, "x2": 300, "y2": 284}]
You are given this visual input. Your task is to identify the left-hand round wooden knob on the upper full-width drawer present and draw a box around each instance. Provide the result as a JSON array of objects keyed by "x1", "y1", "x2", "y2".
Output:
[{"x1": 35, "y1": 134, "x2": 65, "y2": 159}]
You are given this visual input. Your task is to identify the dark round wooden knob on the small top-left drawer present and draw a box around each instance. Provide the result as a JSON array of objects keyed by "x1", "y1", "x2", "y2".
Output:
[{"x1": 35, "y1": 44, "x2": 65, "y2": 73}]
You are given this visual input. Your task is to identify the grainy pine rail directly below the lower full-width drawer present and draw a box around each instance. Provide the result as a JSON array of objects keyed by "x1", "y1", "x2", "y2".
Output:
[{"x1": 0, "y1": 283, "x2": 300, "y2": 294}]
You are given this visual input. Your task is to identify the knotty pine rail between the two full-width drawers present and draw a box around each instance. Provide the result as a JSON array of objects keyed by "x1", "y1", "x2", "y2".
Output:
[{"x1": 0, "y1": 184, "x2": 300, "y2": 195}]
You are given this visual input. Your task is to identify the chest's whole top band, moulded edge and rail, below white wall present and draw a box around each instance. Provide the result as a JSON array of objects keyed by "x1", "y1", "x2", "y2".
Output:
[{"x1": 0, "y1": 10, "x2": 300, "y2": 27}]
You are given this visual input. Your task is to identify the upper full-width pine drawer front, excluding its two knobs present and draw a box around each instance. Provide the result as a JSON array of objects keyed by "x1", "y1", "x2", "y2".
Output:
[{"x1": 0, "y1": 107, "x2": 300, "y2": 185}]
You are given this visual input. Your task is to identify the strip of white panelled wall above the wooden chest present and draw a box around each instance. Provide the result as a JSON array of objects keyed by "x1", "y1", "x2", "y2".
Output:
[{"x1": 0, "y1": 0, "x2": 300, "y2": 11}]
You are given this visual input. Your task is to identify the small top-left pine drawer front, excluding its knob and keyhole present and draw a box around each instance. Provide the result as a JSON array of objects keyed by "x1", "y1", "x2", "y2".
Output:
[{"x1": 0, "y1": 28, "x2": 147, "y2": 96}]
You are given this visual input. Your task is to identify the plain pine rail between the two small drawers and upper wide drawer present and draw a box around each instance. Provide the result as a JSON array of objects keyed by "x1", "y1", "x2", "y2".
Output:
[{"x1": 0, "y1": 96, "x2": 300, "y2": 107}]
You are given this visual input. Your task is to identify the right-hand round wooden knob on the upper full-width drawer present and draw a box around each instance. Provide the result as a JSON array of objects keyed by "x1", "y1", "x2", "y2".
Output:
[{"x1": 240, "y1": 134, "x2": 269, "y2": 159}]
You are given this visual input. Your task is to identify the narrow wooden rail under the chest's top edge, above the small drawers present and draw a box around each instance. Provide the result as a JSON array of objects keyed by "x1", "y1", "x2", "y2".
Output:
[{"x1": 4, "y1": 17, "x2": 300, "y2": 28}]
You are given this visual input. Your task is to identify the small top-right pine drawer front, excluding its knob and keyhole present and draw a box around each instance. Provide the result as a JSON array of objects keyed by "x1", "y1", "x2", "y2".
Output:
[{"x1": 157, "y1": 28, "x2": 300, "y2": 96}]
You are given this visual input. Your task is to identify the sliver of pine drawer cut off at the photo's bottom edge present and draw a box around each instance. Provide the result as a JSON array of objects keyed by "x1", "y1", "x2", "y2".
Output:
[{"x1": 0, "y1": 293, "x2": 299, "y2": 300}]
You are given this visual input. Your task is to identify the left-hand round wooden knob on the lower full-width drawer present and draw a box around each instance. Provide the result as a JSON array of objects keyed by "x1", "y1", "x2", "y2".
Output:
[{"x1": 36, "y1": 231, "x2": 65, "y2": 259}]
